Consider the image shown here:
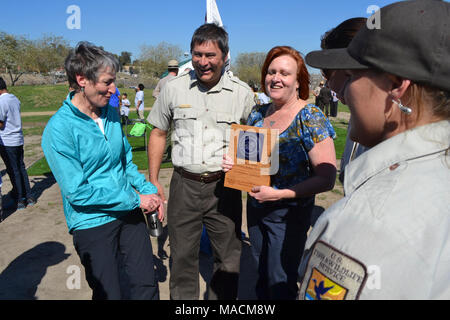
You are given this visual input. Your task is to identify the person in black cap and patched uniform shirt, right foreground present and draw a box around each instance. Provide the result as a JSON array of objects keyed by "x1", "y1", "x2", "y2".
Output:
[{"x1": 299, "y1": 0, "x2": 450, "y2": 300}]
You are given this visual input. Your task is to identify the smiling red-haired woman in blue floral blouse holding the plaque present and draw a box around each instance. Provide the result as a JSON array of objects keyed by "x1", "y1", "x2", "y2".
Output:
[{"x1": 224, "y1": 46, "x2": 336, "y2": 299}]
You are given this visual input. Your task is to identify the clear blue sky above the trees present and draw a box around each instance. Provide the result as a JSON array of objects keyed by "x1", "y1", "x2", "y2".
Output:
[{"x1": 0, "y1": 0, "x2": 410, "y2": 67}]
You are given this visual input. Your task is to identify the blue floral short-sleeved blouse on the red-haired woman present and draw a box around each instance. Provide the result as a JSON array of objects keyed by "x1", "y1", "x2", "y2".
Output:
[{"x1": 247, "y1": 104, "x2": 336, "y2": 189}]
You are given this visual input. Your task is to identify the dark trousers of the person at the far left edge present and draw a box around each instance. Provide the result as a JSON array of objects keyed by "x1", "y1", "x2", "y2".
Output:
[{"x1": 0, "y1": 145, "x2": 31, "y2": 200}]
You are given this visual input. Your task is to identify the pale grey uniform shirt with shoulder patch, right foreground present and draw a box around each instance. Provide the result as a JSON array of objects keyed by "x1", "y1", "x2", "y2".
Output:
[{"x1": 300, "y1": 121, "x2": 450, "y2": 300}]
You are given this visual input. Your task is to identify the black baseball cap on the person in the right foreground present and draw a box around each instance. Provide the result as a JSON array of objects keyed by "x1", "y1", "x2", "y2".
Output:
[{"x1": 305, "y1": 0, "x2": 450, "y2": 91}]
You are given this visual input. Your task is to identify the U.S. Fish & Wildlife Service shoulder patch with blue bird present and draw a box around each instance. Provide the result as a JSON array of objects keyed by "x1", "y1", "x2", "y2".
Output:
[{"x1": 299, "y1": 241, "x2": 367, "y2": 300}]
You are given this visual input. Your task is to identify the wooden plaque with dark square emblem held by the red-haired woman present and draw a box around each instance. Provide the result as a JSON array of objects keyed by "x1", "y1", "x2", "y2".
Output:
[{"x1": 224, "y1": 124, "x2": 278, "y2": 192}]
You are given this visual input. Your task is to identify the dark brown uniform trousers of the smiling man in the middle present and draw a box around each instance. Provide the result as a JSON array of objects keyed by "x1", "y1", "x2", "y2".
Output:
[{"x1": 167, "y1": 171, "x2": 242, "y2": 300}]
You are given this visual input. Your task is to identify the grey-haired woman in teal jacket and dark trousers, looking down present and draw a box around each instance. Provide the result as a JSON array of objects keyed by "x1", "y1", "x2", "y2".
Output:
[{"x1": 42, "y1": 42, "x2": 164, "y2": 299}]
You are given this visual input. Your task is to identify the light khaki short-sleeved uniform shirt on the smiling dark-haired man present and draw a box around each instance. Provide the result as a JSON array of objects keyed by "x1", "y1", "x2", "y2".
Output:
[{"x1": 147, "y1": 71, "x2": 255, "y2": 173}]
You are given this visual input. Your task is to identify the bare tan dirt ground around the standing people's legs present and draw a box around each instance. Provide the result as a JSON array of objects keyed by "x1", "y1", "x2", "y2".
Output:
[{"x1": 0, "y1": 114, "x2": 348, "y2": 300}]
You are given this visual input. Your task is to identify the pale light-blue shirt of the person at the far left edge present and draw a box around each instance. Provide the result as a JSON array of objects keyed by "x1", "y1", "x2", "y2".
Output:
[{"x1": 0, "y1": 93, "x2": 23, "y2": 147}]
